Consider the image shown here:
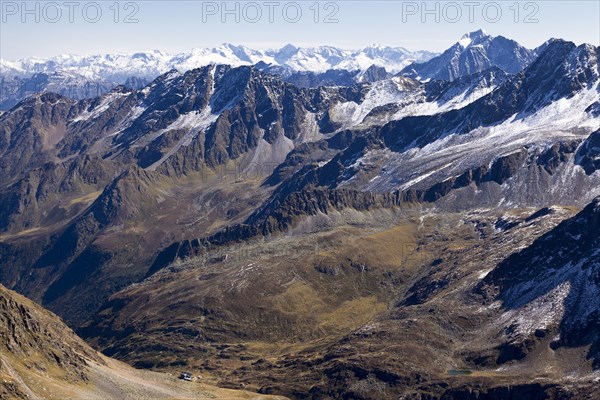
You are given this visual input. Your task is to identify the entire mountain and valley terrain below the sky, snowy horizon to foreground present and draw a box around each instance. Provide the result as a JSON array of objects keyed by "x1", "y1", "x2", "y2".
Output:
[{"x1": 0, "y1": 30, "x2": 600, "y2": 400}]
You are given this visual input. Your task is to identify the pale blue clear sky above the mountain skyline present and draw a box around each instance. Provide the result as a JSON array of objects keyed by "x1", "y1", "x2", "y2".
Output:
[{"x1": 0, "y1": 0, "x2": 600, "y2": 60}]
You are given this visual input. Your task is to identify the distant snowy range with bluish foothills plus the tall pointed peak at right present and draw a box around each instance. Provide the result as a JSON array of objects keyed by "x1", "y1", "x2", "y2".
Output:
[{"x1": 0, "y1": 30, "x2": 543, "y2": 110}]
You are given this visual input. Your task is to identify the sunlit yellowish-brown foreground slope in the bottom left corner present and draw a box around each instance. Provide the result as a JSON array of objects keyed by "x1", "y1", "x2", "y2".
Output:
[{"x1": 0, "y1": 286, "x2": 288, "y2": 400}]
